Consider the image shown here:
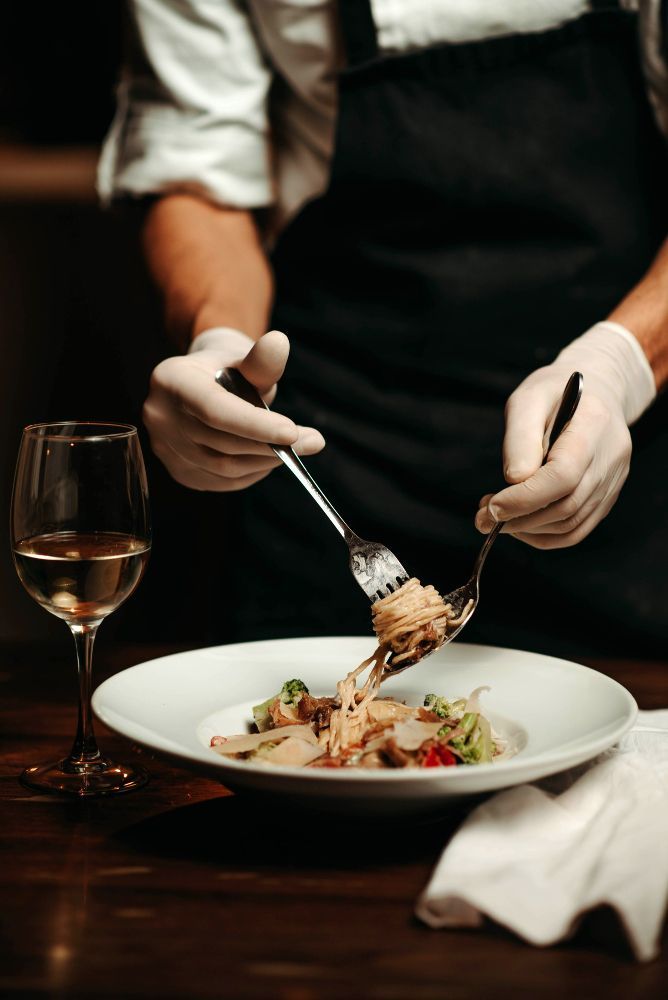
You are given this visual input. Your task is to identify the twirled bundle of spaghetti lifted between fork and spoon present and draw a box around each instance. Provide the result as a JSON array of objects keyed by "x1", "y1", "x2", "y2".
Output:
[{"x1": 371, "y1": 577, "x2": 473, "y2": 667}]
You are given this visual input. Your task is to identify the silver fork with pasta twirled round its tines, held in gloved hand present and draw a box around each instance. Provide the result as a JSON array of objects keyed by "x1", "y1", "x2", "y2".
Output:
[{"x1": 216, "y1": 368, "x2": 409, "y2": 602}]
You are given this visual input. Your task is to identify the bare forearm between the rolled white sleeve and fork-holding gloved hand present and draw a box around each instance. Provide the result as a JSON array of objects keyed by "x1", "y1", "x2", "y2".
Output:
[{"x1": 143, "y1": 194, "x2": 273, "y2": 349}]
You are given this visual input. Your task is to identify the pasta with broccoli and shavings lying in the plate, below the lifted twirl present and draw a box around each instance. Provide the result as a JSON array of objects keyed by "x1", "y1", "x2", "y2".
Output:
[{"x1": 211, "y1": 672, "x2": 503, "y2": 768}]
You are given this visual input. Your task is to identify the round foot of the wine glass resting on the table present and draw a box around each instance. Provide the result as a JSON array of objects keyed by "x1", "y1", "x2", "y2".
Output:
[{"x1": 21, "y1": 757, "x2": 148, "y2": 798}]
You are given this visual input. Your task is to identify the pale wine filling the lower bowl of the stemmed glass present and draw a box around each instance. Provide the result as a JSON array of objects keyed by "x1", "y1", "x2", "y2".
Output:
[{"x1": 14, "y1": 531, "x2": 150, "y2": 624}]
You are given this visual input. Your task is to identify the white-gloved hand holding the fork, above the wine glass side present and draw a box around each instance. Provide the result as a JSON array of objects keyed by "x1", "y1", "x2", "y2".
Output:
[{"x1": 143, "y1": 328, "x2": 325, "y2": 491}]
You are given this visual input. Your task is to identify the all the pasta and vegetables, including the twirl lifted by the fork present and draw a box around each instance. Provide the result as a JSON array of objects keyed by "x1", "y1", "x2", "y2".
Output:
[{"x1": 211, "y1": 578, "x2": 490, "y2": 768}]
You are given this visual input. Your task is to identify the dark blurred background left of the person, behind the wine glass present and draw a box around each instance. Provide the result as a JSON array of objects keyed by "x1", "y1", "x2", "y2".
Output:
[{"x1": 0, "y1": 0, "x2": 234, "y2": 645}]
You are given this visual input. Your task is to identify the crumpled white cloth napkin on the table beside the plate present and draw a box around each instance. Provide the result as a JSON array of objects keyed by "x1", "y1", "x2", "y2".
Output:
[{"x1": 416, "y1": 709, "x2": 668, "y2": 961}]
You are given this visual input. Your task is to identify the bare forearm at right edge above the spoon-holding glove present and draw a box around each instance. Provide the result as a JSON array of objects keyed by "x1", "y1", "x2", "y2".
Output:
[{"x1": 608, "y1": 241, "x2": 668, "y2": 391}]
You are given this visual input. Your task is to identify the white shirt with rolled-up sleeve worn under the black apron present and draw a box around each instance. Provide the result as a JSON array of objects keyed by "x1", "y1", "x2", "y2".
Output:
[{"x1": 98, "y1": 0, "x2": 668, "y2": 228}]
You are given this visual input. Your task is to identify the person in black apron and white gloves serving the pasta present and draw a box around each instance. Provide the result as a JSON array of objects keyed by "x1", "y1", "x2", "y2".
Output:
[{"x1": 100, "y1": 0, "x2": 668, "y2": 655}]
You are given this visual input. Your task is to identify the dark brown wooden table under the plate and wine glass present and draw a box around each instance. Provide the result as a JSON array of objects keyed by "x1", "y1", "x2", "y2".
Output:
[{"x1": 0, "y1": 633, "x2": 668, "y2": 1000}]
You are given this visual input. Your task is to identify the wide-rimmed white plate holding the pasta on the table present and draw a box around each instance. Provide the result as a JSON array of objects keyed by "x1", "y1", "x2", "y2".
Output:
[{"x1": 93, "y1": 636, "x2": 637, "y2": 811}]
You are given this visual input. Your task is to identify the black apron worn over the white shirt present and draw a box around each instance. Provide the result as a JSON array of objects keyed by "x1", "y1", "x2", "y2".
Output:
[{"x1": 230, "y1": 0, "x2": 668, "y2": 655}]
